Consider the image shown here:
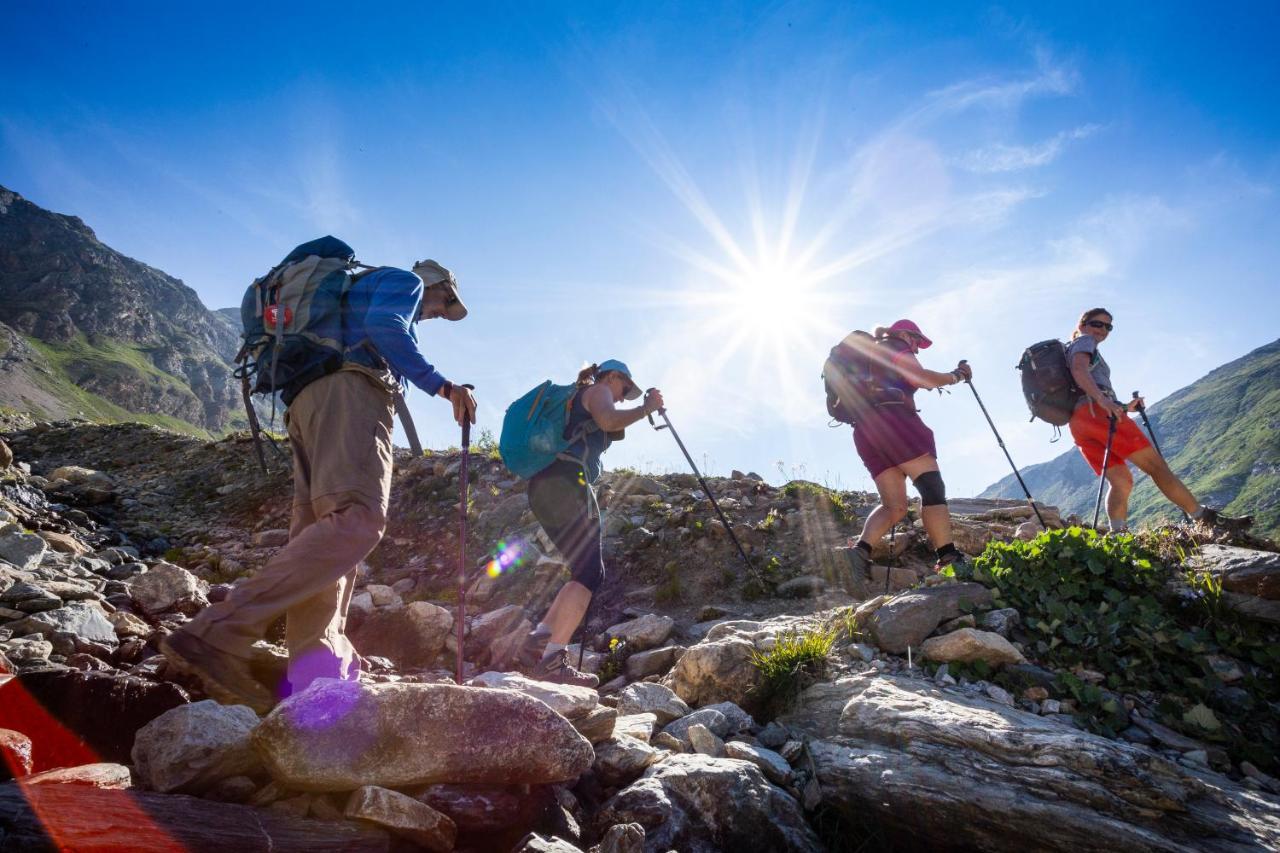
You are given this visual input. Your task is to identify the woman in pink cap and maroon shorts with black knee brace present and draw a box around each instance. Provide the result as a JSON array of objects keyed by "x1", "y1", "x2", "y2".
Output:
[{"x1": 852, "y1": 320, "x2": 973, "y2": 576}]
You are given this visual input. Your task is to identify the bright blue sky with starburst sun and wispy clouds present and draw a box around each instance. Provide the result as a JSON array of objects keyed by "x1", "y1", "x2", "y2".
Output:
[{"x1": 0, "y1": 0, "x2": 1280, "y2": 494}]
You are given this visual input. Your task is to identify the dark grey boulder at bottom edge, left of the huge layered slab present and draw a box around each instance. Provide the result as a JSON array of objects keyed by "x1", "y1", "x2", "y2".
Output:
[{"x1": 595, "y1": 754, "x2": 823, "y2": 853}]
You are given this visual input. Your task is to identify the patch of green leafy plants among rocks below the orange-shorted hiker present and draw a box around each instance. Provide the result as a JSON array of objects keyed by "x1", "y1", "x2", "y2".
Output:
[{"x1": 947, "y1": 528, "x2": 1280, "y2": 767}]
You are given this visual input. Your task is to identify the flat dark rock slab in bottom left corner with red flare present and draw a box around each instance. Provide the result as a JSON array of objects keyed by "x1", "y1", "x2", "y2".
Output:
[{"x1": 0, "y1": 784, "x2": 390, "y2": 853}]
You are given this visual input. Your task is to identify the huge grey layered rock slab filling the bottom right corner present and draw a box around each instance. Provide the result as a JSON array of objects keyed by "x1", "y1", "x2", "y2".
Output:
[{"x1": 781, "y1": 674, "x2": 1280, "y2": 853}]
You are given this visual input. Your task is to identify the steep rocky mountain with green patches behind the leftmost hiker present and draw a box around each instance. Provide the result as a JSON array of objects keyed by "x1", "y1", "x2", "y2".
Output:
[{"x1": 0, "y1": 187, "x2": 243, "y2": 433}]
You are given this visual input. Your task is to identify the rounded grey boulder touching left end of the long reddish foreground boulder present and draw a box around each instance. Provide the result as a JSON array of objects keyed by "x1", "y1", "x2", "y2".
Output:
[{"x1": 133, "y1": 699, "x2": 261, "y2": 794}]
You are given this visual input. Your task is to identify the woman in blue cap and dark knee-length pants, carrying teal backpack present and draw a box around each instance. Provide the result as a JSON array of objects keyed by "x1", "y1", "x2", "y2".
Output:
[{"x1": 520, "y1": 359, "x2": 663, "y2": 686}]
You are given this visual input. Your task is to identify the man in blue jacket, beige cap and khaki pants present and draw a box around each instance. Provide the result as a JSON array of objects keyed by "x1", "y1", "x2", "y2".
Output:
[{"x1": 160, "y1": 260, "x2": 476, "y2": 713}]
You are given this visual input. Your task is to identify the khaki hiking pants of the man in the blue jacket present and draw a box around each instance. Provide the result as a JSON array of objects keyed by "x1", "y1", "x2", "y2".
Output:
[{"x1": 186, "y1": 370, "x2": 394, "y2": 693}]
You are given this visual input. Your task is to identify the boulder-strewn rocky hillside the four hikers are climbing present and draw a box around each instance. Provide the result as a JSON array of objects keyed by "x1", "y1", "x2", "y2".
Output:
[{"x1": 0, "y1": 421, "x2": 1280, "y2": 853}]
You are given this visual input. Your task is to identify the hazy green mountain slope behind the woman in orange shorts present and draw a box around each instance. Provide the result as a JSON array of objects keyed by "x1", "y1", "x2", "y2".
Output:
[{"x1": 982, "y1": 341, "x2": 1280, "y2": 537}]
